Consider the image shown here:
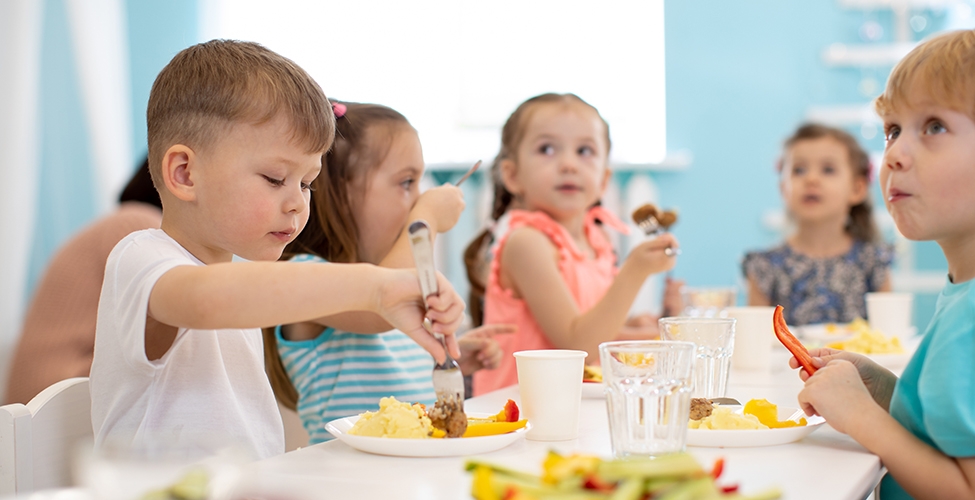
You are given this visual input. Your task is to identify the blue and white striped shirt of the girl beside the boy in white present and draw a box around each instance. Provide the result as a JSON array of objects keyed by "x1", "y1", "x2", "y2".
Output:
[{"x1": 275, "y1": 255, "x2": 437, "y2": 444}]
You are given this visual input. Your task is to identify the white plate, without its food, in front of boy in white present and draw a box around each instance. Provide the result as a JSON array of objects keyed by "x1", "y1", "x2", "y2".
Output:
[{"x1": 325, "y1": 413, "x2": 531, "y2": 457}]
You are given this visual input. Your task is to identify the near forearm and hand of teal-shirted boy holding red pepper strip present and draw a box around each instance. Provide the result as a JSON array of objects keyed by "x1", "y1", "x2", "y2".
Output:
[{"x1": 799, "y1": 360, "x2": 975, "y2": 499}]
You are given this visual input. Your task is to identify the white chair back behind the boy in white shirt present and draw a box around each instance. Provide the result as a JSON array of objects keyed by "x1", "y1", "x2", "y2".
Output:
[{"x1": 0, "y1": 377, "x2": 94, "y2": 495}]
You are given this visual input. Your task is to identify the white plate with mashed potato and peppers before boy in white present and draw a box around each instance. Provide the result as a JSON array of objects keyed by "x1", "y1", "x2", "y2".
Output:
[{"x1": 325, "y1": 397, "x2": 531, "y2": 457}]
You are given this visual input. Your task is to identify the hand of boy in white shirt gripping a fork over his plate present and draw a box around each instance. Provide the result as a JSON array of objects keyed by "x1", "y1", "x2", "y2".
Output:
[{"x1": 376, "y1": 269, "x2": 466, "y2": 363}]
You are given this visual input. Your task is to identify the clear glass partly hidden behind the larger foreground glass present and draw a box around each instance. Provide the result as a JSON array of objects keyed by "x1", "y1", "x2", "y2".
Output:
[{"x1": 658, "y1": 317, "x2": 735, "y2": 399}]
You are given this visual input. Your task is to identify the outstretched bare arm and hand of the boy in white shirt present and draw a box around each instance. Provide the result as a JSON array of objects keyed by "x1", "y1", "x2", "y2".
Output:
[{"x1": 149, "y1": 262, "x2": 465, "y2": 361}]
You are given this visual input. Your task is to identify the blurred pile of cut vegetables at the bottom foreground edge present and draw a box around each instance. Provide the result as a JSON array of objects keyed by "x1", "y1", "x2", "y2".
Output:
[{"x1": 465, "y1": 451, "x2": 782, "y2": 500}]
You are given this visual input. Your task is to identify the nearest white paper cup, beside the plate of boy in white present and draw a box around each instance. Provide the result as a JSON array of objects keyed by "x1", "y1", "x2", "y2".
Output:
[{"x1": 515, "y1": 349, "x2": 588, "y2": 441}]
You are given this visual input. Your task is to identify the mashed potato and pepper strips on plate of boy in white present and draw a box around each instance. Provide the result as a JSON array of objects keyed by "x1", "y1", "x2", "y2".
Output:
[{"x1": 349, "y1": 396, "x2": 528, "y2": 439}]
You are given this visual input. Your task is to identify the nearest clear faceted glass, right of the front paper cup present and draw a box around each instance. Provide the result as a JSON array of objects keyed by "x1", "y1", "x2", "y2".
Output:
[{"x1": 599, "y1": 340, "x2": 696, "y2": 458}]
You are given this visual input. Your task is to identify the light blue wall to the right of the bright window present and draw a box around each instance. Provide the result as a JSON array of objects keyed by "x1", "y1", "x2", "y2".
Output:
[{"x1": 655, "y1": 0, "x2": 946, "y2": 326}]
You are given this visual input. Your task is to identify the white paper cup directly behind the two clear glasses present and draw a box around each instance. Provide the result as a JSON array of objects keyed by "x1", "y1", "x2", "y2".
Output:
[{"x1": 724, "y1": 306, "x2": 775, "y2": 371}]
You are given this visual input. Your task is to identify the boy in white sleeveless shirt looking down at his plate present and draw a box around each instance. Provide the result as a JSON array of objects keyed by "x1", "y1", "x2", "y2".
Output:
[{"x1": 91, "y1": 40, "x2": 464, "y2": 459}]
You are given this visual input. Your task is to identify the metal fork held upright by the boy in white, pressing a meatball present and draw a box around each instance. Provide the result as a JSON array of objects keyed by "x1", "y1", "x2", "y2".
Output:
[{"x1": 409, "y1": 220, "x2": 464, "y2": 403}]
